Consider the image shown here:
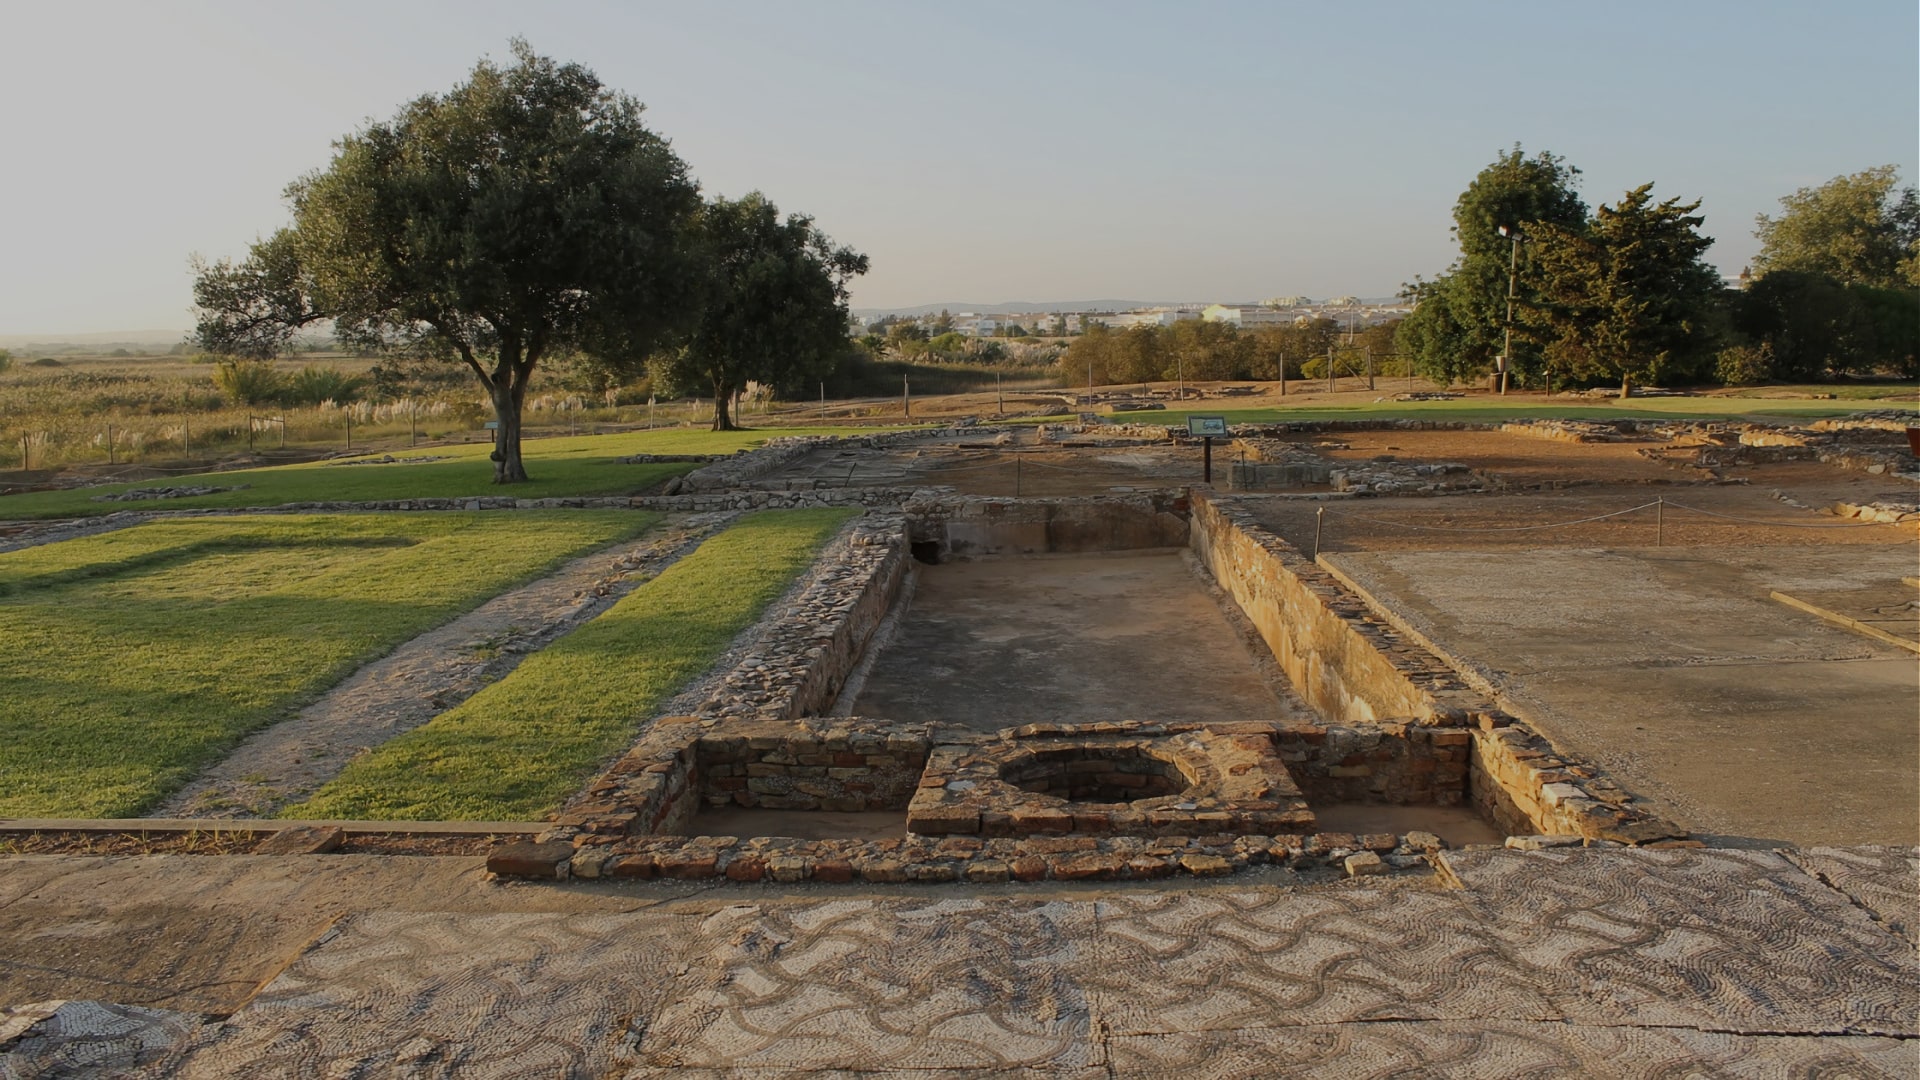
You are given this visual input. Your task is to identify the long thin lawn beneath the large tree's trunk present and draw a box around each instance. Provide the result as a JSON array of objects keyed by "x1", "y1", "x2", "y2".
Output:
[{"x1": 0, "y1": 429, "x2": 906, "y2": 521}]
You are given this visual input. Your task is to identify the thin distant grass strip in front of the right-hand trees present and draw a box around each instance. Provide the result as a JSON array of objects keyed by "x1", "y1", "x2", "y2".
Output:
[{"x1": 1114, "y1": 396, "x2": 1899, "y2": 427}]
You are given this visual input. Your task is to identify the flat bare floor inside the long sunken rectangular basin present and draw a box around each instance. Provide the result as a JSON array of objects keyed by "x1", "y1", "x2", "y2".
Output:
[{"x1": 851, "y1": 553, "x2": 1309, "y2": 732}]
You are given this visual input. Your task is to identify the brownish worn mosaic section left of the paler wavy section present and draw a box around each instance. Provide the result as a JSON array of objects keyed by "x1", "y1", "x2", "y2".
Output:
[{"x1": 169, "y1": 913, "x2": 699, "y2": 1080}]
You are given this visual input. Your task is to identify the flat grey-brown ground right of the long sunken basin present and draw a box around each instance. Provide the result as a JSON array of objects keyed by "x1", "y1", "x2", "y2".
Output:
[{"x1": 1325, "y1": 544, "x2": 1920, "y2": 846}]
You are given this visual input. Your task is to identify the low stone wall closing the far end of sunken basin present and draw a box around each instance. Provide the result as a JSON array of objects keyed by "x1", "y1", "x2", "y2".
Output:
[{"x1": 902, "y1": 490, "x2": 1188, "y2": 557}]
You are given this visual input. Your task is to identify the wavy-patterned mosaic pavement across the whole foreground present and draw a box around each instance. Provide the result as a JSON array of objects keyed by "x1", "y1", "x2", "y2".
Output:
[{"x1": 0, "y1": 847, "x2": 1920, "y2": 1078}]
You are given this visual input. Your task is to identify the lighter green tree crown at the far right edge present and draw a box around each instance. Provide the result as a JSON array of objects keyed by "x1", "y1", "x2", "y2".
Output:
[{"x1": 1753, "y1": 165, "x2": 1920, "y2": 288}]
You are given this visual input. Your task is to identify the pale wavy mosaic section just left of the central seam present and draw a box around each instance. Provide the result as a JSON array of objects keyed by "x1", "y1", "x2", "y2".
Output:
[{"x1": 632, "y1": 899, "x2": 1102, "y2": 1072}]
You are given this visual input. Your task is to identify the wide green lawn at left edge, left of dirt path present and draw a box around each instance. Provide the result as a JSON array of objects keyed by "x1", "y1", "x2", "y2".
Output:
[{"x1": 0, "y1": 511, "x2": 660, "y2": 817}]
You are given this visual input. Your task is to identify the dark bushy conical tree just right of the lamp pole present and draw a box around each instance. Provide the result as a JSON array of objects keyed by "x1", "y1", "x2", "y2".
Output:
[{"x1": 1524, "y1": 184, "x2": 1722, "y2": 398}]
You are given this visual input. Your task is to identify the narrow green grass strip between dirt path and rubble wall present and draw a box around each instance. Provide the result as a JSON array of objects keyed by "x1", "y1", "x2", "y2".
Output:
[{"x1": 280, "y1": 509, "x2": 856, "y2": 821}]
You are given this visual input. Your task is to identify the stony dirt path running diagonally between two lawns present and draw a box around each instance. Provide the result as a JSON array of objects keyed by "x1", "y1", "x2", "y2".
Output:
[{"x1": 154, "y1": 513, "x2": 733, "y2": 819}]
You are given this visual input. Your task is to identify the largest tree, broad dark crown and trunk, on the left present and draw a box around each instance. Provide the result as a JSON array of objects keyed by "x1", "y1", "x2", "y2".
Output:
[{"x1": 194, "y1": 40, "x2": 699, "y2": 482}]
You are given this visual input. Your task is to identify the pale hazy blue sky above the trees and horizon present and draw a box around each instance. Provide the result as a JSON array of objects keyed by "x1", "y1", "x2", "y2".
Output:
[{"x1": 0, "y1": 0, "x2": 1920, "y2": 334}]
